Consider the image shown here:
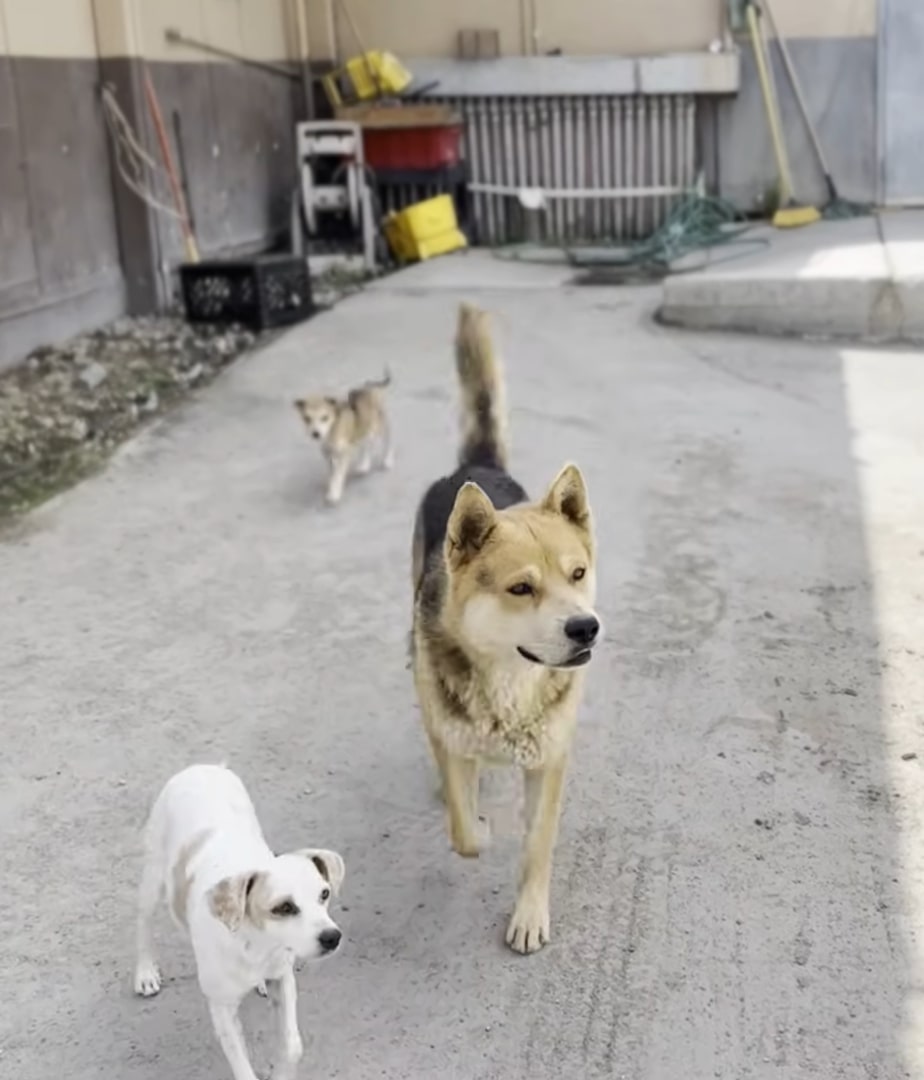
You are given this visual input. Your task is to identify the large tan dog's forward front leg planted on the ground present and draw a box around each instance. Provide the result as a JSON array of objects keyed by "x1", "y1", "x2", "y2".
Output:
[{"x1": 506, "y1": 756, "x2": 568, "y2": 953}]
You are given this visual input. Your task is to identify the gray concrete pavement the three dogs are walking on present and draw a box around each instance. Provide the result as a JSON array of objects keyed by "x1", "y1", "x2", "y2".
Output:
[{"x1": 0, "y1": 248, "x2": 924, "y2": 1080}]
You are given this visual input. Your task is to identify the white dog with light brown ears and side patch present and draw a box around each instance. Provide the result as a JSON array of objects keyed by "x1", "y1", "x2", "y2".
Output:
[{"x1": 135, "y1": 765, "x2": 344, "y2": 1080}]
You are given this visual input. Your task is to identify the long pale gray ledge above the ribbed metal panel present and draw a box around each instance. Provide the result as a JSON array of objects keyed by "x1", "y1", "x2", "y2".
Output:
[{"x1": 407, "y1": 51, "x2": 740, "y2": 97}]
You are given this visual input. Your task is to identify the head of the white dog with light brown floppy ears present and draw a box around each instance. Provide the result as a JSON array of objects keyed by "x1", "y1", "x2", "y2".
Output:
[{"x1": 208, "y1": 848, "x2": 345, "y2": 960}]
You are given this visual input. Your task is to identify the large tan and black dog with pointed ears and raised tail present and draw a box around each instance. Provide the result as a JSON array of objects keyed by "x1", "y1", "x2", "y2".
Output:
[{"x1": 411, "y1": 306, "x2": 601, "y2": 953}]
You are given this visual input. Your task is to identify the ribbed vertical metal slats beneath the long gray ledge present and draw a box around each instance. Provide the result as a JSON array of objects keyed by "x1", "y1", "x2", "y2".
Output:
[{"x1": 386, "y1": 95, "x2": 696, "y2": 244}]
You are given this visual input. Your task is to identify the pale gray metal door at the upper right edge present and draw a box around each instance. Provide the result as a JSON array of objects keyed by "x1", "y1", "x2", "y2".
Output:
[{"x1": 879, "y1": 0, "x2": 924, "y2": 206}]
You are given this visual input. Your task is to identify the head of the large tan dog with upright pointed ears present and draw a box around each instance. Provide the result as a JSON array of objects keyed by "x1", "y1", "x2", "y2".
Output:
[{"x1": 444, "y1": 465, "x2": 601, "y2": 667}]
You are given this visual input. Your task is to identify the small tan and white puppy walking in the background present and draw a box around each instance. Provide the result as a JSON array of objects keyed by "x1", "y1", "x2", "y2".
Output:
[{"x1": 295, "y1": 372, "x2": 395, "y2": 505}]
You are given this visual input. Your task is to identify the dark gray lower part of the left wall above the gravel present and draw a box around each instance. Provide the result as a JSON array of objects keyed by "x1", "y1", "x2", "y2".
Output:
[{"x1": 0, "y1": 55, "x2": 300, "y2": 368}]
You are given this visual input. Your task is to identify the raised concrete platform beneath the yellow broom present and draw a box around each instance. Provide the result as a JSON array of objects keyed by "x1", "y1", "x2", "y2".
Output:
[{"x1": 663, "y1": 211, "x2": 924, "y2": 342}]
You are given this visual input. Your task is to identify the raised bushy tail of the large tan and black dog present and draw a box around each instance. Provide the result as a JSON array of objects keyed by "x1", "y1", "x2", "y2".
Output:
[{"x1": 456, "y1": 303, "x2": 507, "y2": 469}]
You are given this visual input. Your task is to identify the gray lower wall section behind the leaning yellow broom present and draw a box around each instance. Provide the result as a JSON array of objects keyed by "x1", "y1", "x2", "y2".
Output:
[{"x1": 704, "y1": 37, "x2": 877, "y2": 208}]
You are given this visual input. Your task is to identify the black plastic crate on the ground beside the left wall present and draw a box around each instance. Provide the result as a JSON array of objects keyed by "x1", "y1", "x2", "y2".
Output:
[{"x1": 180, "y1": 255, "x2": 314, "y2": 330}]
